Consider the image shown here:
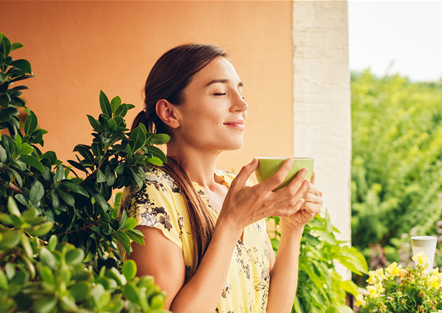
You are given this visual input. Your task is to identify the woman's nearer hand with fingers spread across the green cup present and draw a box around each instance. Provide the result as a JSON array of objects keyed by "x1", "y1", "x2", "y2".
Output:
[{"x1": 217, "y1": 158, "x2": 310, "y2": 232}]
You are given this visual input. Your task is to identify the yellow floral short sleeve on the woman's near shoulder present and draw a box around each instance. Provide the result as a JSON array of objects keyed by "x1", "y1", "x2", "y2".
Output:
[{"x1": 122, "y1": 170, "x2": 187, "y2": 249}]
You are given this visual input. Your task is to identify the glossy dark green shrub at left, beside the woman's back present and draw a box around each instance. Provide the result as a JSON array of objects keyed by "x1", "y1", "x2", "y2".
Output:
[{"x1": 0, "y1": 33, "x2": 169, "y2": 313}]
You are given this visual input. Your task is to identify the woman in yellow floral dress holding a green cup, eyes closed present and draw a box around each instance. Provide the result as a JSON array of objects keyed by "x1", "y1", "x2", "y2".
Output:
[{"x1": 119, "y1": 44, "x2": 322, "y2": 313}]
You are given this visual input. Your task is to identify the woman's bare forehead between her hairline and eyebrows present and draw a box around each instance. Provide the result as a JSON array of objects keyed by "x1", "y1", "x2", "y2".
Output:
[{"x1": 191, "y1": 57, "x2": 241, "y2": 88}]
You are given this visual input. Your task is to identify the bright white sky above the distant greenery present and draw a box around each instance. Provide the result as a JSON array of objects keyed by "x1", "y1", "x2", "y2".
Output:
[{"x1": 348, "y1": 0, "x2": 442, "y2": 81}]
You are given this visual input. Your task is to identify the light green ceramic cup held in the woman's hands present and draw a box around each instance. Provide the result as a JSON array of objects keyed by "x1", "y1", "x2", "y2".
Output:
[{"x1": 255, "y1": 157, "x2": 315, "y2": 191}]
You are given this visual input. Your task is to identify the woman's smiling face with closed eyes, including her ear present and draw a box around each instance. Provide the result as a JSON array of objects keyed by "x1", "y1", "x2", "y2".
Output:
[{"x1": 174, "y1": 57, "x2": 248, "y2": 152}]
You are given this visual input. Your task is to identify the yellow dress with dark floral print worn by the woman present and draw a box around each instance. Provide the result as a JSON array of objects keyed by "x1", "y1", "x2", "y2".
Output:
[{"x1": 118, "y1": 169, "x2": 273, "y2": 313}]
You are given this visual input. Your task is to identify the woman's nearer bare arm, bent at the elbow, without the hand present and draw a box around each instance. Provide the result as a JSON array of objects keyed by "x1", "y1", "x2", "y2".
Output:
[{"x1": 130, "y1": 225, "x2": 241, "y2": 313}]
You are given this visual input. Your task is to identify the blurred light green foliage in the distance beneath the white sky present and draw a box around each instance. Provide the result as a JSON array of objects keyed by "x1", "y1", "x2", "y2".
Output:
[{"x1": 351, "y1": 71, "x2": 442, "y2": 262}]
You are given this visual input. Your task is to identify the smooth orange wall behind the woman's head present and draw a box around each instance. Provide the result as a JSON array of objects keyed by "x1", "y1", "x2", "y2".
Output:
[{"x1": 0, "y1": 1, "x2": 293, "y2": 171}]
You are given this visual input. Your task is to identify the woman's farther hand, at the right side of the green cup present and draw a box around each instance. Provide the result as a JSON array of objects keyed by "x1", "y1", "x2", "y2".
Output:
[{"x1": 281, "y1": 172, "x2": 323, "y2": 230}]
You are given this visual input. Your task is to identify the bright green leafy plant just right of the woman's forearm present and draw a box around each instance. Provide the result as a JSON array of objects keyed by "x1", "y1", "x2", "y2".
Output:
[{"x1": 269, "y1": 208, "x2": 367, "y2": 313}]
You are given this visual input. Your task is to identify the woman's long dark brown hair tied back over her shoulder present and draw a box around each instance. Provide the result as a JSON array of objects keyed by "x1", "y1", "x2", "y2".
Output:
[{"x1": 131, "y1": 44, "x2": 226, "y2": 282}]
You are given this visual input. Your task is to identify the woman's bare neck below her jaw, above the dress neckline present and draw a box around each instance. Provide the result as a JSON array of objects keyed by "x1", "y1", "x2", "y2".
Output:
[{"x1": 167, "y1": 142, "x2": 221, "y2": 190}]
